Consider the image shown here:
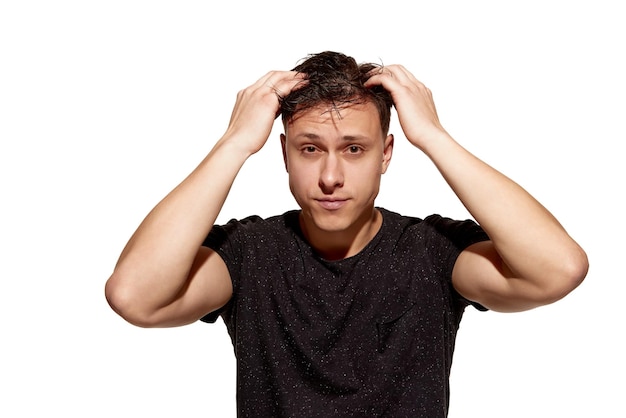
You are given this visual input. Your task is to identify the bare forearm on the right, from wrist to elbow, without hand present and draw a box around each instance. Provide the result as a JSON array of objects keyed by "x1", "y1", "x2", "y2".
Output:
[{"x1": 424, "y1": 133, "x2": 585, "y2": 282}]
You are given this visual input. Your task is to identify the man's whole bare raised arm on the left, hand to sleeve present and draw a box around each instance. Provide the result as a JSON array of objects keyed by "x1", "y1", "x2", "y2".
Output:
[{"x1": 105, "y1": 71, "x2": 302, "y2": 327}]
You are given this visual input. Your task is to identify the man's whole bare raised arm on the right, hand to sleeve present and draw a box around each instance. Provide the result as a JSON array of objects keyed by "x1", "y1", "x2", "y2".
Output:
[{"x1": 368, "y1": 65, "x2": 588, "y2": 312}]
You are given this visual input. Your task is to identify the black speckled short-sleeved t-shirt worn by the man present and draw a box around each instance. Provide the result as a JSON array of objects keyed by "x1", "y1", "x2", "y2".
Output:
[{"x1": 202, "y1": 208, "x2": 488, "y2": 418}]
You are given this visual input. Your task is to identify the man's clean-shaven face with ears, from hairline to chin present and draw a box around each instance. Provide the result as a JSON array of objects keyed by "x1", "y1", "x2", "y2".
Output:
[{"x1": 281, "y1": 103, "x2": 393, "y2": 234}]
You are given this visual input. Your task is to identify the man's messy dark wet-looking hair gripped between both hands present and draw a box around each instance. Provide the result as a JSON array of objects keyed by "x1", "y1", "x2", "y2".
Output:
[{"x1": 280, "y1": 51, "x2": 393, "y2": 135}]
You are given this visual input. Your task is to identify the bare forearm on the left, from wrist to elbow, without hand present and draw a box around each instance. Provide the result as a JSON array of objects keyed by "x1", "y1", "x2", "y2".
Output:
[{"x1": 109, "y1": 139, "x2": 248, "y2": 310}]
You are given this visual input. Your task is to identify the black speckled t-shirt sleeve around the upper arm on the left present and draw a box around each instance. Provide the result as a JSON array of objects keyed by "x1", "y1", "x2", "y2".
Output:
[{"x1": 200, "y1": 217, "x2": 257, "y2": 323}]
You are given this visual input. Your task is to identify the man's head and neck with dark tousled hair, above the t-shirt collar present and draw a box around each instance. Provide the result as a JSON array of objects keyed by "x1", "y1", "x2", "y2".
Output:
[{"x1": 281, "y1": 52, "x2": 393, "y2": 258}]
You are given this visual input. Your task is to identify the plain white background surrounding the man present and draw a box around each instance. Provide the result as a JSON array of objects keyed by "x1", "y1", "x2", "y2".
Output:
[{"x1": 0, "y1": 0, "x2": 626, "y2": 418}]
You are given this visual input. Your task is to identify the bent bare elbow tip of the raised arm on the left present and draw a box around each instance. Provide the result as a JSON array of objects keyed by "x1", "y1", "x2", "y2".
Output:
[{"x1": 104, "y1": 273, "x2": 156, "y2": 328}]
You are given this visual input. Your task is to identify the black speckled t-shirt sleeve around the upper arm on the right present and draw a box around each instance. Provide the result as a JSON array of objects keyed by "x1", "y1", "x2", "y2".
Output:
[{"x1": 424, "y1": 215, "x2": 489, "y2": 311}]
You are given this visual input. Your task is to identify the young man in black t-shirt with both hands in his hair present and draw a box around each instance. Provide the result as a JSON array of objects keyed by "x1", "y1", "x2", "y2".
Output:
[{"x1": 106, "y1": 52, "x2": 588, "y2": 418}]
